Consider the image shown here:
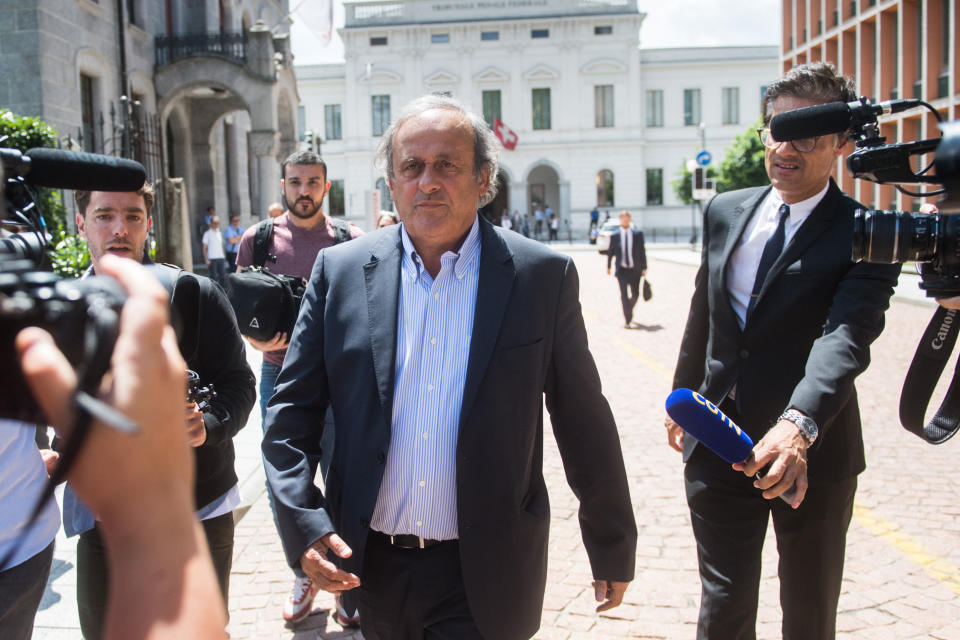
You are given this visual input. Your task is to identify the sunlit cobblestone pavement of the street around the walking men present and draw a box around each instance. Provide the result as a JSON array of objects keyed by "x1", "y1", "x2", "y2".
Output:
[{"x1": 35, "y1": 248, "x2": 960, "y2": 640}]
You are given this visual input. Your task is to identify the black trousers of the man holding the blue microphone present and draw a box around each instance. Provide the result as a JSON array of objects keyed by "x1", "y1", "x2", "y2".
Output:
[{"x1": 684, "y1": 416, "x2": 857, "y2": 640}]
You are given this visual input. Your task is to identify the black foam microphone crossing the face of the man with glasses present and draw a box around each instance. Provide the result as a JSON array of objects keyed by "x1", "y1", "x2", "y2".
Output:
[{"x1": 770, "y1": 98, "x2": 922, "y2": 142}]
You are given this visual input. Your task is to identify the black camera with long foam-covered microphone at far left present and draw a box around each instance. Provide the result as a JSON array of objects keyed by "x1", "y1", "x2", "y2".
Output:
[{"x1": 0, "y1": 146, "x2": 146, "y2": 423}]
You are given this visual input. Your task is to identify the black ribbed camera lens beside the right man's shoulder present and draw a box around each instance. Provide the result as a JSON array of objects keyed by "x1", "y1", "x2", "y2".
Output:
[{"x1": 853, "y1": 209, "x2": 940, "y2": 264}]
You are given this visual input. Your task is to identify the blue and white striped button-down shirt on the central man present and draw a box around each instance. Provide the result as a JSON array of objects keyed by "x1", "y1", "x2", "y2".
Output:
[{"x1": 370, "y1": 220, "x2": 480, "y2": 540}]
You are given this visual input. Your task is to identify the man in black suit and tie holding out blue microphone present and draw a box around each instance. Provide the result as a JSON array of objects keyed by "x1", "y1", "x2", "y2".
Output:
[{"x1": 666, "y1": 63, "x2": 899, "y2": 640}]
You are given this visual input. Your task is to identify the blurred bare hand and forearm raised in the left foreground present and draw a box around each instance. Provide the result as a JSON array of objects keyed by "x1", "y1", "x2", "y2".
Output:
[{"x1": 16, "y1": 256, "x2": 226, "y2": 640}]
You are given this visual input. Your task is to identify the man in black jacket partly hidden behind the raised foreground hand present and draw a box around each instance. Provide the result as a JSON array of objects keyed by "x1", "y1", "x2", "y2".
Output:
[{"x1": 63, "y1": 183, "x2": 256, "y2": 640}]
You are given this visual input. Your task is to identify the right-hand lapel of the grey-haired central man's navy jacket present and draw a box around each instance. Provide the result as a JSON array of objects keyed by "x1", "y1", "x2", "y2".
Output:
[{"x1": 459, "y1": 216, "x2": 516, "y2": 429}]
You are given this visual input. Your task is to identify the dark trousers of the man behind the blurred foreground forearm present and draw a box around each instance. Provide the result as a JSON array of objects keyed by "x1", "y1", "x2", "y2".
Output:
[{"x1": 77, "y1": 513, "x2": 234, "y2": 640}]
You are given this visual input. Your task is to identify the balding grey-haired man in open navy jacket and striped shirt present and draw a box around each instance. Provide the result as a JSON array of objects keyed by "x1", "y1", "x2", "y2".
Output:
[{"x1": 263, "y1": 95, "x2": 637, "y2": 640}]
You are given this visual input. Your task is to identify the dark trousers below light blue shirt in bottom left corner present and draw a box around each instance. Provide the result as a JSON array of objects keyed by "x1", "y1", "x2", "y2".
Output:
[{"x1": 0, "y1": 542, "x2": 53, "y2": 640}]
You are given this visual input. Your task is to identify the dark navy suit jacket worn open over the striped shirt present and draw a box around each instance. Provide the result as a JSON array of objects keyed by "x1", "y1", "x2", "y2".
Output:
[{"x1": 263, "y1": 218, "x2": 637, "y2": 639}]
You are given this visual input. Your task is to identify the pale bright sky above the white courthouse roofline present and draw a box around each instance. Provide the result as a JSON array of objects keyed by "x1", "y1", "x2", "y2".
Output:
[{"x1": 290, "y1": 0, "x2": 780, "y2": 64}]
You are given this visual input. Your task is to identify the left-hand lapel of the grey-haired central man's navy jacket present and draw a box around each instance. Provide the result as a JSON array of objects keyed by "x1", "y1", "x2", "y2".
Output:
[{"x1": 363, "y1": 225, "x2": 403, "y2": 421}]
